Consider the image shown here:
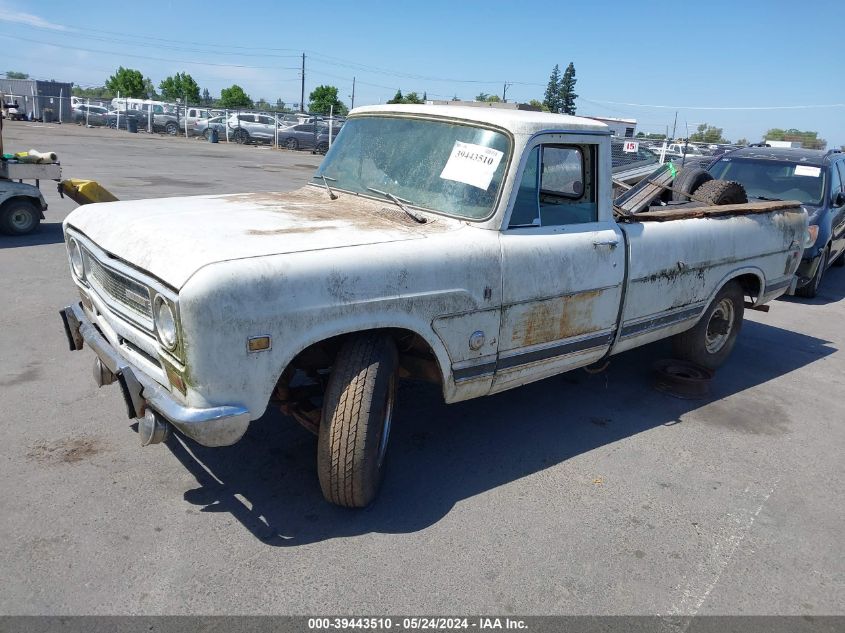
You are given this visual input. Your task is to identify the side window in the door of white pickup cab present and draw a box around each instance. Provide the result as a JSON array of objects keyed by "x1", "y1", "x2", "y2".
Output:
[{"x1": 510, "y1": 145, "x2": 598, "y2": 227}]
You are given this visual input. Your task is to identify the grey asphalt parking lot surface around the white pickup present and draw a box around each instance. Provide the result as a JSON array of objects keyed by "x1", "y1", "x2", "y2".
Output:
[{"x1": 0, "y1": 123, "x2": 845, "y2": 616}]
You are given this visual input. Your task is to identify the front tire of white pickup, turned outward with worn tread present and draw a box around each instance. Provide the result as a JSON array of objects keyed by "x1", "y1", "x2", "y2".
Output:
[{"x1": 317, "y1": 332, "x2": 398, "y2": 508}]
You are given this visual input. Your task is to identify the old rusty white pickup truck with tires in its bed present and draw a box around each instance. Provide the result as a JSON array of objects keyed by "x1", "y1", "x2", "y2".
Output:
[{"x1": 56, "y1": 105, "x2": 807, "y2": 507}]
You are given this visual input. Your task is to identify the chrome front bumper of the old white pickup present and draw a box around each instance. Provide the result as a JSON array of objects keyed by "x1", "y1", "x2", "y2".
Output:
[{"x1": 59, "y1": 304, "x2": 249, "y2": 446}]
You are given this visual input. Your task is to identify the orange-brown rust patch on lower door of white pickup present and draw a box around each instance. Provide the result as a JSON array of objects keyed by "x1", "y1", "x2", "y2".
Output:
[{"x1": 511, "y1": 290, "x2": 602, "y2": 347}]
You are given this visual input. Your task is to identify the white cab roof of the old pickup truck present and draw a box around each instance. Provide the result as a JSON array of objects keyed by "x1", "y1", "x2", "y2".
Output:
[{"x1": 349, "y1": 104, "x2": 610, "y2": 134}]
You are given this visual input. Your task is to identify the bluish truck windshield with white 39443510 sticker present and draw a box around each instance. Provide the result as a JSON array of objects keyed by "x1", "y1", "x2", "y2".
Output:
[{"x1": 314, "y1": 116, "x2": 510, "y2": 219}]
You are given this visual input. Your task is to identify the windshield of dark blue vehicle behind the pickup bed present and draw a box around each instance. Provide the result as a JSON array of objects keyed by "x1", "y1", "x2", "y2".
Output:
[{"x1": 709, "y1": 158, "x2": 824, "y2": 205}]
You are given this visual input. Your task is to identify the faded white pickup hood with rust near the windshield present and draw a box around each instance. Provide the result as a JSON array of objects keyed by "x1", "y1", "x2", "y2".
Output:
[{"x1": 65, "y1": 186, "x2": 463, "y2": 290}]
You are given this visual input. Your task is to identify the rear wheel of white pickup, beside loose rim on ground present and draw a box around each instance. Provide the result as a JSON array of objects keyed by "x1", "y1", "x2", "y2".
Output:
[{"x1": 672, "y1": 281, "x2": 745, "y2": 369}]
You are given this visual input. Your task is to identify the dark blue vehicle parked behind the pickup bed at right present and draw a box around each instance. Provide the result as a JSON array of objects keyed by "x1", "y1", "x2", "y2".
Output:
[{"x1": 708, "y1": 147, "x2": 845, "y2": 297}]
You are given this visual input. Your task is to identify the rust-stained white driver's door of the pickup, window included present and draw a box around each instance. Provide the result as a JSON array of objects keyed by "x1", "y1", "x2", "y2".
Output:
[{"x1": 492, "y1": 134, "x2": 625, "y2": 392}]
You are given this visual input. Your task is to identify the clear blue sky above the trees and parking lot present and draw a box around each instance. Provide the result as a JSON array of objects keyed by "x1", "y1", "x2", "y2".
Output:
[{"x1": 0, "y1": 0, "x2": 845, "y2": 147}]
